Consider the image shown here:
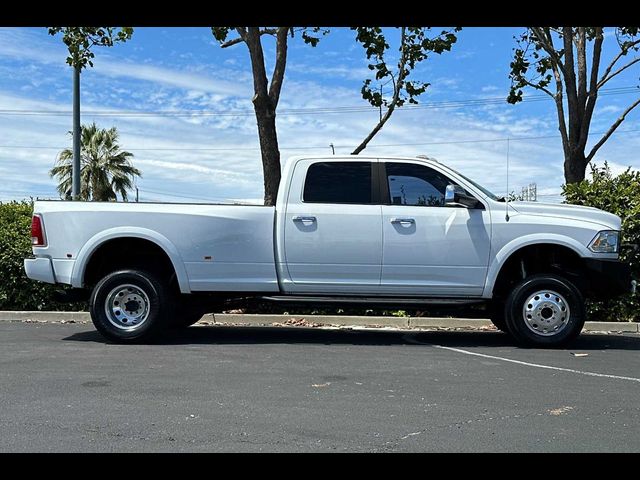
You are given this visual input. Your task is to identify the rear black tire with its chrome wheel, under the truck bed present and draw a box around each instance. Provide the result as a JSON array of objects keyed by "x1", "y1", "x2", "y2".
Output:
[{"x1": 89, "y1": 270, "x2": 174, "y2": 343}]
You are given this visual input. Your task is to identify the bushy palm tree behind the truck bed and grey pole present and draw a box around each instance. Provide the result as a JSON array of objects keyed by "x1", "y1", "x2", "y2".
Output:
[{"x1": 49, "y1": 123, "x2": 142, "y2": 202}]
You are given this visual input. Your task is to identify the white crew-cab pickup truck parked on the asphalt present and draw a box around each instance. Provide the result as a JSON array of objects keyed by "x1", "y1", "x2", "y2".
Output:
[{"x1": 25, "y1": 156, "x2": 635, "y2": 346}]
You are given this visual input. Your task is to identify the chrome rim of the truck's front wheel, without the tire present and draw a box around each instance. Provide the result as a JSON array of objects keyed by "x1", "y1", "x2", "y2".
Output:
[{"x1": 522, "y1": 290, "x2": 571, "y2": 337}]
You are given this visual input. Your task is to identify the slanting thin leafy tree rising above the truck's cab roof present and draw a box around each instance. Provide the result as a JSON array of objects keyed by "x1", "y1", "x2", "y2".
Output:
[{"x1": 351, "y1": 27, "x2": 461, "y2": 155}]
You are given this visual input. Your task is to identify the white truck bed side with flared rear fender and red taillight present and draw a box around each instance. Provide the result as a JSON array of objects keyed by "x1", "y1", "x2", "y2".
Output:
[{"x1": 34, "y1": 201, "x2": 278, "y2": 293}]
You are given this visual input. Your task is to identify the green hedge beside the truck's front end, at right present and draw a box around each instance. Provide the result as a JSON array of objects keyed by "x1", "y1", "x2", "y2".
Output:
[{"x1": 563, "y1": 163, "x2": 640, "y2": 322}]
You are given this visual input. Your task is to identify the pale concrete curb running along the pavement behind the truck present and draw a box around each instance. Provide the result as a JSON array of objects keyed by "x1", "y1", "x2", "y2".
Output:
[{"x1": 0, "y1": 311, "x2": 640, "y2": 333}]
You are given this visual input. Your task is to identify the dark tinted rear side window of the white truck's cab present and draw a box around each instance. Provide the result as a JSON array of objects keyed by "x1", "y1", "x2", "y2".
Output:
[{"x1": 302, "y1": 162, "x2": 371, "y2": 204}]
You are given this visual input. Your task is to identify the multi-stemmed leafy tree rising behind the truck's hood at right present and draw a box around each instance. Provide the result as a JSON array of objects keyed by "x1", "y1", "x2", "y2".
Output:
[{"x1": 507, "y1": 27, "x2": 640, "y2": 183}]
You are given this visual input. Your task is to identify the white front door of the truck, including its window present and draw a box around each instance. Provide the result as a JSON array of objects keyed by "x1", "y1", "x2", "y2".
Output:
[{"x1": 381, "y1": 161, "x2": 491, "y2": 296}]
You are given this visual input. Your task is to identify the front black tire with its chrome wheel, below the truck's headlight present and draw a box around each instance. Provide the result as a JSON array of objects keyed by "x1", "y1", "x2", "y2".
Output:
[{"x1": 504, "y1": 274, "x2": 585, "y2": 347}]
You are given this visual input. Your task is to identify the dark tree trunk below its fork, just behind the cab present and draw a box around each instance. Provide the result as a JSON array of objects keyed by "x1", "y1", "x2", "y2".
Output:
[{"x1": 254, "y1": 97, "x2": 280, "y2": 205}]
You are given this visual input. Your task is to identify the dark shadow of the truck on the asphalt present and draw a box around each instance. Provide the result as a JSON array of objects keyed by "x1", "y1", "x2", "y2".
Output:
[{"x1": 63, "y1": 326, "x2": 640, "y2": 350}]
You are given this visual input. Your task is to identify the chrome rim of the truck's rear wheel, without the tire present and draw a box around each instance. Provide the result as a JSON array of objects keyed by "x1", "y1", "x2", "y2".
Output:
[{"x1": 104, "y1": 284, "x2": 150, "y2": 331}]
